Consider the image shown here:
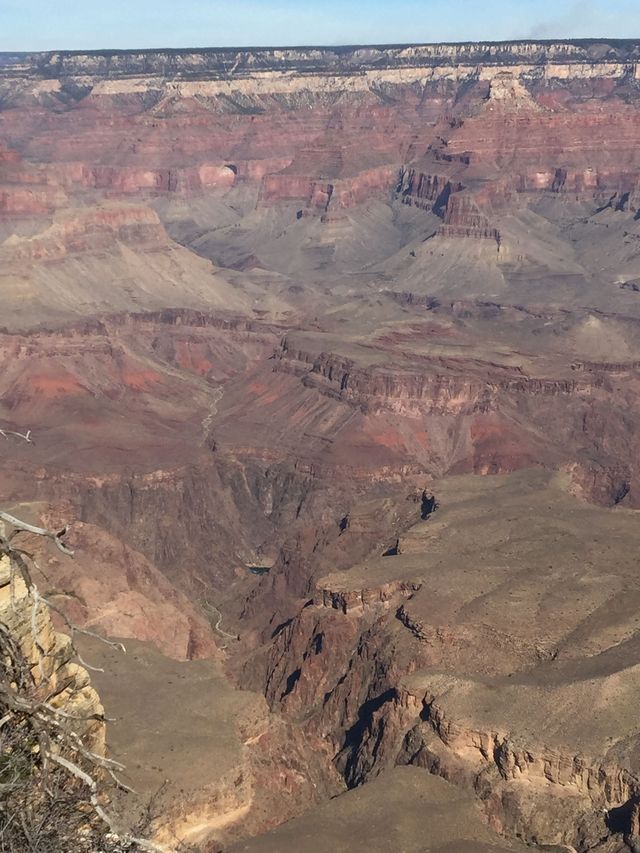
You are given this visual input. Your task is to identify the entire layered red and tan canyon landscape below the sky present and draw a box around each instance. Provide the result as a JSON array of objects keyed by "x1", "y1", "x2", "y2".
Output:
[{"x1": 0, "y1": 40, "x2": 640, "y2": 853}]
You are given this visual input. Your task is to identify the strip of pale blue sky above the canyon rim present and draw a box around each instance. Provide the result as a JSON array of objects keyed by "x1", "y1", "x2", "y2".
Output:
[{"x1": 0, "y1": 0, "x2": 640, "y2": 50}]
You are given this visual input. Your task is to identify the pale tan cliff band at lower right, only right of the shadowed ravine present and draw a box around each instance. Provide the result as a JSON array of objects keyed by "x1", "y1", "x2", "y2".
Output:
[{"x1": 396, "y1": 676, "x2": 638, "y2": 850}]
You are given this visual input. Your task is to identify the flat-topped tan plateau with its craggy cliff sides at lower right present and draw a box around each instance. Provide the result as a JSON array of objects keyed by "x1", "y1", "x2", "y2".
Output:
[{"x1": 239, "y1": 473, "x2": 639, "y2": 851}]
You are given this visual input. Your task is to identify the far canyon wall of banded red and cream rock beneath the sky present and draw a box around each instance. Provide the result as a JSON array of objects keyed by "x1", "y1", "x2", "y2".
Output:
[{"x1": 0, "y1": 41, "x2": 639, "y2": 233}]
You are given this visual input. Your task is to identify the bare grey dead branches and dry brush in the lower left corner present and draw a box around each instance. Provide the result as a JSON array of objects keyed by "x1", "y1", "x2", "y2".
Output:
[{"x1": 0, "y1": 510, "x2": 163, "y2": 853}]
